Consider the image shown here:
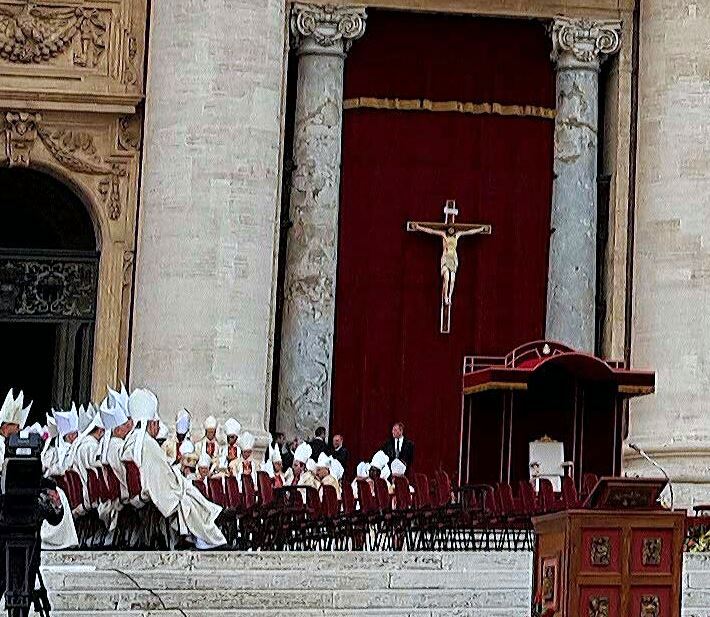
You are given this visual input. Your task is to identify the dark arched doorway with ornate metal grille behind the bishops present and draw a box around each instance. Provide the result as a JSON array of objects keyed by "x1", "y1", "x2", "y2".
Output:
[{"x1": 0, "y1": 168, "x2": 99, "y2": 419}]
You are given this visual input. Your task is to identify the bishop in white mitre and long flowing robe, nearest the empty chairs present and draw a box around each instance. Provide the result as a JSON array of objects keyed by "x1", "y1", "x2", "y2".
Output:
[{"x1": 121, "y1": 390, "x2": 226, "y2": 549}]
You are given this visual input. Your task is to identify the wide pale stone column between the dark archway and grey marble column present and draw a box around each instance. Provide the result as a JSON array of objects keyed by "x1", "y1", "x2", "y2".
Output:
[{"x1": 131, "y1": 0, "x2": 286, "y2": 442}]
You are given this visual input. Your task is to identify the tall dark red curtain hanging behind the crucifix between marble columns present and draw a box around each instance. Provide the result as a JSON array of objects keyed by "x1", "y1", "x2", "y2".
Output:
[{"x1": 332, "y1": 11, "x2": 554, "y2": 471}]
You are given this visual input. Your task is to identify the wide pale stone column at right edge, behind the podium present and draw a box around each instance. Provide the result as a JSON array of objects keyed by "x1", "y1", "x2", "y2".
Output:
[{"x1": 625, "y1": 0, "x2": 710, "y2": 507}]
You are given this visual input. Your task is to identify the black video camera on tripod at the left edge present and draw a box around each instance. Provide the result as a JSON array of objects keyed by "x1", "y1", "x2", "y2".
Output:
[{"x1": 0, "y1": 433, "x2": 62, "y2": 617}]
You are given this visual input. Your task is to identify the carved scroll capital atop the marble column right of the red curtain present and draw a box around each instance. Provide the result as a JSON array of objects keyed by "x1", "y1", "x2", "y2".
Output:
[{"x1": 552, "y1": 17, "x2": 621, "y2": 68}]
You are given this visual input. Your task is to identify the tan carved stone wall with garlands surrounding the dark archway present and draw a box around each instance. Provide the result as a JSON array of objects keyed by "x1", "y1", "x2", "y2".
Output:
[{"x1": 0, "y1": 0, "x2": 146, "y2": 399}]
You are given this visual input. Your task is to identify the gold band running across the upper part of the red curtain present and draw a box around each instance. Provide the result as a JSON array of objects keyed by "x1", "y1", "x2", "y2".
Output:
[{"x1": 343, "y1": 96, "x2": 555, "y2": 120}]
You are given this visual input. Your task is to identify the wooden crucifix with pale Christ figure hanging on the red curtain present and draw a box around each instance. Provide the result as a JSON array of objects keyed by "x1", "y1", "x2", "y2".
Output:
[{"x1": 407, "y1": 199, "x2": 493, "y2": 334}]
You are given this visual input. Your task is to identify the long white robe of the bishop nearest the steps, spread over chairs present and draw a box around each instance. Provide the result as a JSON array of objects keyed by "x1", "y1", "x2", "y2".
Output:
[{"x1": 140, "y1": 435, "x2": 227, "y2": 548}]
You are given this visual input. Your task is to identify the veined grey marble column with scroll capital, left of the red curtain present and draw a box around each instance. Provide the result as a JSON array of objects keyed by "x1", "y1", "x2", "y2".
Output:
[{"x1": 278, "y1": 4, "x2": 366, "y2": 436}]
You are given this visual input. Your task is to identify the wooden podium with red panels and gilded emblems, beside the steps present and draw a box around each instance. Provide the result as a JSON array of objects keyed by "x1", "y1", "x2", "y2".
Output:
[{"x1": 533, "y1": 478, "x2": 685, "y2": 617}]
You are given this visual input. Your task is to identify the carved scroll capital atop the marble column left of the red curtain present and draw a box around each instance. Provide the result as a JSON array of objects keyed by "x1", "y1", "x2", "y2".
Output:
[{"x1": 291, "y1": 2, "x2": 367, "y2": 55}]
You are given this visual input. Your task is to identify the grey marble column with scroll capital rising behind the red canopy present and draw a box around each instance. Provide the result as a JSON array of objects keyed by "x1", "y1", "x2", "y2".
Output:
[{"x1": 546, "y1": 17, "x2": 621, "y2": 353}]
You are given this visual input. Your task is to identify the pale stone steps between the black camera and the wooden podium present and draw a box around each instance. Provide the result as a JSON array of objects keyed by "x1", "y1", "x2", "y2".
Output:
[{"x1": 32, "y1": 551, "x2": 531, "y2": 617}]
